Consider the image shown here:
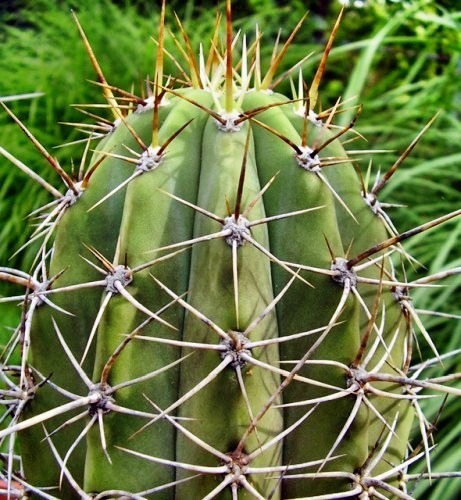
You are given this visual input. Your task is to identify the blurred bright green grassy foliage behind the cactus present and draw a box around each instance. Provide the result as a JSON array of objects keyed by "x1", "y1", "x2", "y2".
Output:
[{"x1": 0, "y1": 0, "x2": 461, "y2": 499}]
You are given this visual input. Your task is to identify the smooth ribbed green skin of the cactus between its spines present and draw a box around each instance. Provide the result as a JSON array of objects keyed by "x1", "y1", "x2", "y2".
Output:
[{"x1": 17, "y1": 86, "x2": 411, "y2": 499}]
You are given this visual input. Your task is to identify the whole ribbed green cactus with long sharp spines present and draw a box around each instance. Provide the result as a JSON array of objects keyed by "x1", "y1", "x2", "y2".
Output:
[{"x1": 0, "y1": 0, "x2": 461, "y2": 499}]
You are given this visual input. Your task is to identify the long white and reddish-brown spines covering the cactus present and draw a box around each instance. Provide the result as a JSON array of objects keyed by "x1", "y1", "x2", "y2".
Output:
[{"x1": 0, "y1": 2, "x2": 461, "y2": 498}]
